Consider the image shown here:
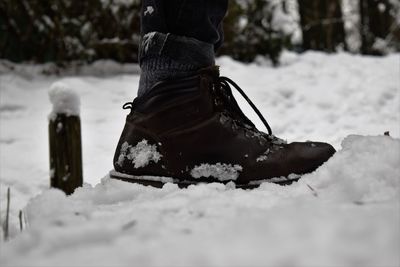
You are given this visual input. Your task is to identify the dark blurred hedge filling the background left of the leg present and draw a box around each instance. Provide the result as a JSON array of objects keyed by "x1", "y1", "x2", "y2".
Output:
[{"x1": 0, "y1": 0, "x2": 140, "y2": 63}]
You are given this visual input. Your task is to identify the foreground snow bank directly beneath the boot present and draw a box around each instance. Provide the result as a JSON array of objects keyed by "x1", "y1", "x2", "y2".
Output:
[{"x1": 0, "y1": 136, "x2": 400, "y2": 266}]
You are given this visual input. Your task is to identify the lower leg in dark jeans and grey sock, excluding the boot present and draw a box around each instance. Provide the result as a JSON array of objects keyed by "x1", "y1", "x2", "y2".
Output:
[{"x1": 138, "y1": 0, "x2": 228, "y2": 96}]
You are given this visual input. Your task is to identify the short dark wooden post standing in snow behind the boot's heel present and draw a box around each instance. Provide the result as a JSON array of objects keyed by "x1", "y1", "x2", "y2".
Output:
[{"x1": 49, "y1": 82, "x2": 83, "y2": 195}]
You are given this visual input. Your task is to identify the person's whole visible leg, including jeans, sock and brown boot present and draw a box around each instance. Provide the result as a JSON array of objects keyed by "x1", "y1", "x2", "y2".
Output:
[{"x1": 110, "y1": 0, "x2": 335, "y2": 188}]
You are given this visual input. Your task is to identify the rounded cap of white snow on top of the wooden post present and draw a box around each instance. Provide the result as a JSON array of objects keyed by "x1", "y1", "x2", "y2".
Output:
[{"x1": 49, "y1": 82, "x2": 80, "y2": 120}]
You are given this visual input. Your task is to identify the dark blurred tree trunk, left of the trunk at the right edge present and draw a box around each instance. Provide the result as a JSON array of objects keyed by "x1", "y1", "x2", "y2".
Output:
[{"x1": 298, "y1": 0, "x2": 347, "y2": 52}]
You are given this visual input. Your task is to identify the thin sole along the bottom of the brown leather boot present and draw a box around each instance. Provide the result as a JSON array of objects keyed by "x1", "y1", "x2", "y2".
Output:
[{"x1": 109, "y1": 170, "x2": 301, "y2": 189}]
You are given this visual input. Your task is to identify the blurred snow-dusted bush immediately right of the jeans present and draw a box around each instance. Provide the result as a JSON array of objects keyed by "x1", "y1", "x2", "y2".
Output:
[{"x1": 220, "y1": 0, "x2": 296, "y2": 65}]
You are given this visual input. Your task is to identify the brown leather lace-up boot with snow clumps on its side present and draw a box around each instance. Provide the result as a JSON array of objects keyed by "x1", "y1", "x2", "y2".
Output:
[{"x1": 110, "y1": 67, "x2": 335, "y2": 188}]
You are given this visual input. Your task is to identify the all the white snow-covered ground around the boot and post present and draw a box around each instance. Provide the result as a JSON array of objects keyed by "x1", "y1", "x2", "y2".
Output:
[{"x1": 0, "y1": 52, "x2": 400, "y2": 266}]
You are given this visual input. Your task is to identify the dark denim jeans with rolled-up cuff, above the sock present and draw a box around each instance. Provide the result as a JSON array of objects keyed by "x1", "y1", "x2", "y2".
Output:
[{"x1": 140, "y1": 0, "x2": 228, "y2": 65}]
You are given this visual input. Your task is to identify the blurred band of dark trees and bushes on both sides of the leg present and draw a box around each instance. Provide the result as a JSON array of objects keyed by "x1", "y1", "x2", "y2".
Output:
[{"x1": 0, "y1": 0, "x2": 400, "y2": 65}]
